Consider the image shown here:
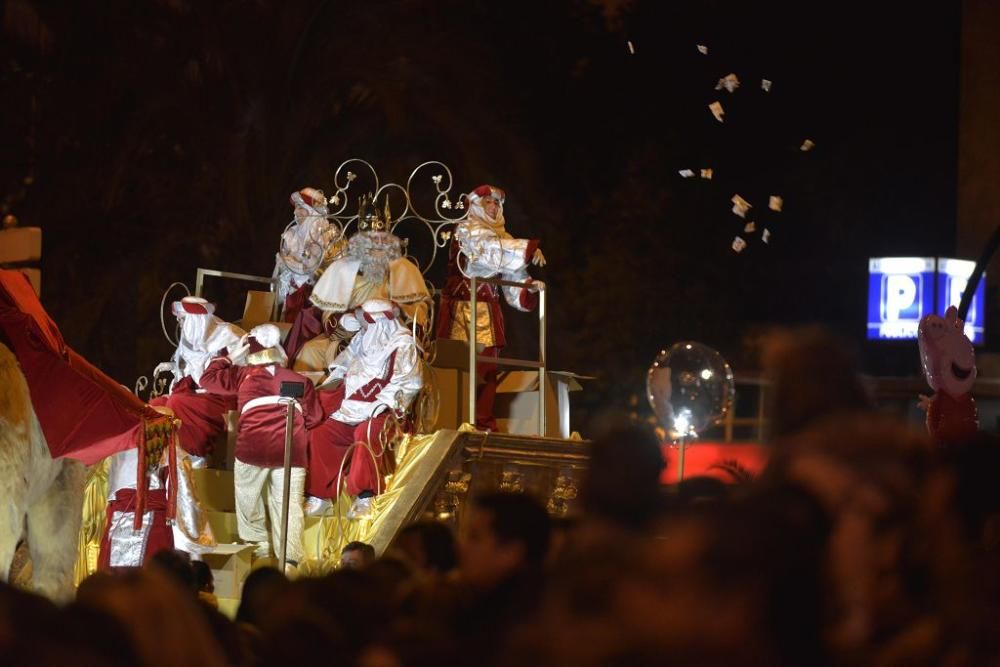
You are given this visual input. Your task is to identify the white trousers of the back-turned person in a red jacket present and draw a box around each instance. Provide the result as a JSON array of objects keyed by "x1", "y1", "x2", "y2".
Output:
[{"x1": 233, "y1": 459, "x2": 306, "y2": 563}]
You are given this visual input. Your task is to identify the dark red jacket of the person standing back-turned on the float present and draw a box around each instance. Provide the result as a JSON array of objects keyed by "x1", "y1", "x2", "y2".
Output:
[{"x1": 201, "y1": 357, "x2": 326, "y2": 468}]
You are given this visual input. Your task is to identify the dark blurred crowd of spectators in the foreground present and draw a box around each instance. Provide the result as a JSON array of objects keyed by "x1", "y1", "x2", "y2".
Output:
[{"x1": 0, "y1": 331, "x2": 1000, "y2": 667}]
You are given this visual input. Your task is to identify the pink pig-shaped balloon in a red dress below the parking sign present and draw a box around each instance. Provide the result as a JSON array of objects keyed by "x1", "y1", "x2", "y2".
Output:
[{"x1": 917, "y1": 306, "x2": 979, "y2": 446}]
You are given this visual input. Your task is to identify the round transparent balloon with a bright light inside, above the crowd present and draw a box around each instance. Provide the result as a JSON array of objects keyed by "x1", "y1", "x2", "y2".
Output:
[{"x1": 646, "y1": 341, "x2": 735, "y2": 442}]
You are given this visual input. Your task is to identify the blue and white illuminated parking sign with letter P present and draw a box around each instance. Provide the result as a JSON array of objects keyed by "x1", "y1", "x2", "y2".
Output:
[{"x1": 868, "y1": 257, "x2": 986, "y2": 343}]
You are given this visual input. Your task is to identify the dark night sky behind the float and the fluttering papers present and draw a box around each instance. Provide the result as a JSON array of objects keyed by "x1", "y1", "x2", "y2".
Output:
[{"x1": 0, "y1": 0, "x2": 960, "y2": 422}]
